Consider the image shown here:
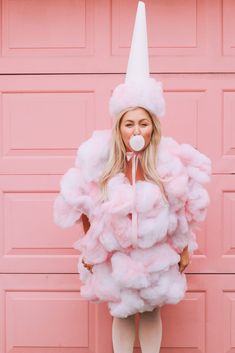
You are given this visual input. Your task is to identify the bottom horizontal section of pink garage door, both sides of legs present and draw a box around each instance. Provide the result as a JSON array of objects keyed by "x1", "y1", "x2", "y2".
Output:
[{"x1": 0, "y1": 274, "x2": 235, "y2": 353}]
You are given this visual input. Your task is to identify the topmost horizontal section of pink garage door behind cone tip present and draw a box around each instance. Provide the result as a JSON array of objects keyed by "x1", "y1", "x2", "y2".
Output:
[{"x1": 0, "y1": 0, "x2": 235, "y2": 73}]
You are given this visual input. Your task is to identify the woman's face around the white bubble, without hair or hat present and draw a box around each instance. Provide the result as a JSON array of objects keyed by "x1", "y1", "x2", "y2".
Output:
[{"x1": 120, "y1": 108, "x2": 153, "y2": 151}]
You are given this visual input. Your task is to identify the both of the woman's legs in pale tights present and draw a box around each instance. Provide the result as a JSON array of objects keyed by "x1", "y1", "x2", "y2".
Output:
[{"x1": 112, "y1": 308, "x2": 162, "y2": 353}]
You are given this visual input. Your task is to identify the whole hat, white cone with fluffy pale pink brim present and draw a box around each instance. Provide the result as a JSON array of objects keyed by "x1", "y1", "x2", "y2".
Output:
[{"x1": 109, "y1": 1, "x2": 165, "y2": 120}]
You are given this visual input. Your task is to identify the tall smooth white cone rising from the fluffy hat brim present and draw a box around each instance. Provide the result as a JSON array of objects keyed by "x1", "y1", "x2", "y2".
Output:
[{"x1": 125, "y1": 1, "x2": 149, "y2": 82}]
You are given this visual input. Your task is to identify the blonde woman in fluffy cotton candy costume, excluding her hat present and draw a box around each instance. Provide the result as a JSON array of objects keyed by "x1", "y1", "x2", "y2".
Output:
[{"x1": 54, "y1": 103, "x2": 210, "y2": 353}]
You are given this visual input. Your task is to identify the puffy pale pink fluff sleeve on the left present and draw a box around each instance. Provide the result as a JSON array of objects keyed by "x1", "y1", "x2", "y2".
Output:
[{"x1": 54, "y1": 130, "x2": 111, "y2": 228}]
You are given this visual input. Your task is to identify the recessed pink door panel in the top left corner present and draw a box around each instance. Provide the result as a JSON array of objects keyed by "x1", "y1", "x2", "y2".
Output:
[{"x1": 2, "y1": 0, "x2": 94, "y2": 57}]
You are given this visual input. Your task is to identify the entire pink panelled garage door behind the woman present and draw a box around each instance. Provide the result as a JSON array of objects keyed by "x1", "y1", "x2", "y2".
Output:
[{"x1": 0, "y1": 0, "x2": 235, "y2": 353}]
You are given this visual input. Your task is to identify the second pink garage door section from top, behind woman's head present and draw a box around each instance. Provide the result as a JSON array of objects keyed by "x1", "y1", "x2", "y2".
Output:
[{"x1": 0, "y1": 74, "x2": 235, "y2": 174}]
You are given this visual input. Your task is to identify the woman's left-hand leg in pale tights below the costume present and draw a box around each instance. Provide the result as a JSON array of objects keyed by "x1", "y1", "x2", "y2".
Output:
[{"x1": 112, "y1": 315, "x2": 135, "y2": 353}]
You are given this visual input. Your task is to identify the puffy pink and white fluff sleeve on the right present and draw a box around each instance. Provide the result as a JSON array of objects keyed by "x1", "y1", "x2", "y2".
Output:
[{"x1": 167, "y1": 144, "x2": 211, "y2": 255}]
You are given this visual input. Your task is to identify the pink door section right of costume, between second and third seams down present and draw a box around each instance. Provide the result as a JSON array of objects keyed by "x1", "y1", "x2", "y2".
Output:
[{"x1": 189, "y1": 174, "x2": 235, "y2": 273}]
